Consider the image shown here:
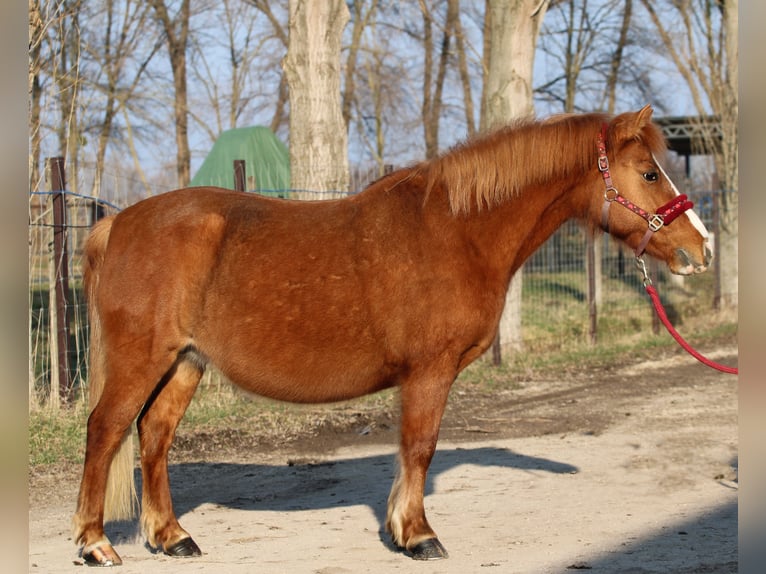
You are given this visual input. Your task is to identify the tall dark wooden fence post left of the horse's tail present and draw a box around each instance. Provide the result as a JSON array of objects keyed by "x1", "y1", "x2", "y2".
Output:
[{"x1": 48, "y1": 157, "x2": 72, "y2": 403}]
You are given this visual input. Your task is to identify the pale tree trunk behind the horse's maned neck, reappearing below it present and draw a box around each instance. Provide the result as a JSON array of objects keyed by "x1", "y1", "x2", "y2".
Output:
[{"x1": 481, "y1": 0, "x2": 548, "y2": 358}]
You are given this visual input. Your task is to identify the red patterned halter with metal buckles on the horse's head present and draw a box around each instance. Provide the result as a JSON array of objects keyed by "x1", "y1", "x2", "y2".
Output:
[{"x1": 596, "y1": 124, "x2": 694, "y2": 257}]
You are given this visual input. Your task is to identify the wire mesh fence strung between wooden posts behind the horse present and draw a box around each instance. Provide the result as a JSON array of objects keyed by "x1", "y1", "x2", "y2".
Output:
[{"x1": 29, "y1": 162, "x2": 728, "y2": 408}]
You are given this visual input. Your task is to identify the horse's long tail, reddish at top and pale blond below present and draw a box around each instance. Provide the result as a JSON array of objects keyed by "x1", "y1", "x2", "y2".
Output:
[{"x1": 83, "y1": 216, "x2": 138, "y2": 520}]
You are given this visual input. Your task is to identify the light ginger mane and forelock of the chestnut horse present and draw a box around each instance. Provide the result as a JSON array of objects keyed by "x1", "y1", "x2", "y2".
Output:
[{"x1": 428, "y1": 113, "x2": 665, "y2": 214}]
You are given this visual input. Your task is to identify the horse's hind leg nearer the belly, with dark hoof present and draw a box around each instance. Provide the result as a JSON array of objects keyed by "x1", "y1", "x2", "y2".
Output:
[{"x1": 138, "y1": 353, "x2": 204, "y2": 556}]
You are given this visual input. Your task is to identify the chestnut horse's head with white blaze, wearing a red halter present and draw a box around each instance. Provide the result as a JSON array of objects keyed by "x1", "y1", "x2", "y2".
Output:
[{"x1": 596, "y1": 106, "x2": 712, "y2": 275}]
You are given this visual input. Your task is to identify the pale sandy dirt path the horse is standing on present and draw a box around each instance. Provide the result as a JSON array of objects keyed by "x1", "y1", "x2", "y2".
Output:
[{"x1": 29, "y1": 346, "x2": 738, "y2": 574}]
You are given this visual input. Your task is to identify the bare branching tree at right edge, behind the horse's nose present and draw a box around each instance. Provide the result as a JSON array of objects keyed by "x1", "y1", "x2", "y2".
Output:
[{"x1": 641, "y1": 0, "x2": 739, "y2": 308}]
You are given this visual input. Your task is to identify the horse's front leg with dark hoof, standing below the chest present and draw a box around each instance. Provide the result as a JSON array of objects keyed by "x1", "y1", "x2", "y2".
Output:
[{"x1": 386, "y1": 368, "x2": 454, "y2": 560}]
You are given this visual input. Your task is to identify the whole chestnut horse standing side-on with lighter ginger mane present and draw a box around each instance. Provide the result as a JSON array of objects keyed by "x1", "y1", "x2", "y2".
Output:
[{"x1": 74, "y1": 106, "x2": 711, "y2": 565}]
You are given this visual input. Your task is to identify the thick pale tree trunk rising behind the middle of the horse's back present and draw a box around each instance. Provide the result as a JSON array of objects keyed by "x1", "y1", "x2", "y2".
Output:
[{"x1": 283, "y1": 0, "x2": 350, "y2": 198}]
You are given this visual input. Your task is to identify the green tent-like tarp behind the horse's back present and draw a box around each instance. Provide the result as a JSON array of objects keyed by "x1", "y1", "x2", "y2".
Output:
[{"x1": 190, "y1": 126, "x2": 290, "y2": 197}]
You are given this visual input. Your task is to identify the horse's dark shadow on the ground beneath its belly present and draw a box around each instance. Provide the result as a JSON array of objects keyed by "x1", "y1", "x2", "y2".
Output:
[{"x1": 115, "y1": 447, "x2": 578, "y2": 541}]
